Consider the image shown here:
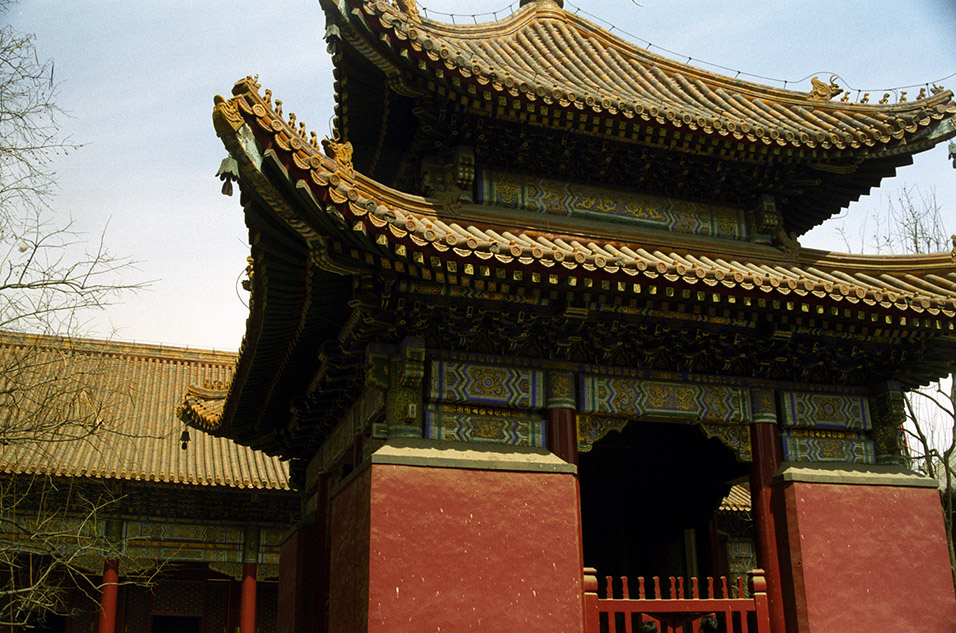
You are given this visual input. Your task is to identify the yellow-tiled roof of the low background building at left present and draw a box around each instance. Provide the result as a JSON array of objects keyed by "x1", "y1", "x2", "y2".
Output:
[{"x1": 0, "y1": 333, "x2": 289, "y2": 490}]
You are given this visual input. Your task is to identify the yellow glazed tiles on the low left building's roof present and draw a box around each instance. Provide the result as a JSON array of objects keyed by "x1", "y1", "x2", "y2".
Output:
[{"x1": 0, "y1": 333, "x2": 289, "y2": 490}]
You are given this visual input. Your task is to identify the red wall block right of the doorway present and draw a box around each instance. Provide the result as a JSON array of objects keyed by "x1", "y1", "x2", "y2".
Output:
[{"x1": 783, "y1": 482, "x2": 956, "y2": 633}]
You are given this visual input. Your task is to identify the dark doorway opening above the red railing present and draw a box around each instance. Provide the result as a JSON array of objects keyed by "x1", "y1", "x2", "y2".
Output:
[{"x1": 578, "y1": 421, "x2": 750, "y2": 578}]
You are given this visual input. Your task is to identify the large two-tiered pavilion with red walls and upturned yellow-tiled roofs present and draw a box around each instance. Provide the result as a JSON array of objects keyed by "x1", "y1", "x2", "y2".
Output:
[{"x1": 183, "y1": 0, "x2": 956, "y2": 633}]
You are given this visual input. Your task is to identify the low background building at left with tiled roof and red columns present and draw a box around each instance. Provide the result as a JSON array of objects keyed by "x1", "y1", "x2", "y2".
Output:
[{"x1": 0, "y1": 333, "x2": 299, "y2": 633}]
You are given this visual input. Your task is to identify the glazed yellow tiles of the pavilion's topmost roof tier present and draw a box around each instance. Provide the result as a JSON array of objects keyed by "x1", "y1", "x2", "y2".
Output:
[{"x1": 340, "y1": 0, "x2": 956, "y2": 156}]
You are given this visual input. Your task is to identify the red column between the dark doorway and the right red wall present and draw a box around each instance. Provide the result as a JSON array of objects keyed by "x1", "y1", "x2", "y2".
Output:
[{"x1": 750, "y1": 389, "x2": 786, "y2": 633}]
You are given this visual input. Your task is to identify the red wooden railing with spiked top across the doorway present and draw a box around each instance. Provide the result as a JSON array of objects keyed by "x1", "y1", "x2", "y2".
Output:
[{"x1": 584, "y1": 567, "x2": 770, "y2": 633}]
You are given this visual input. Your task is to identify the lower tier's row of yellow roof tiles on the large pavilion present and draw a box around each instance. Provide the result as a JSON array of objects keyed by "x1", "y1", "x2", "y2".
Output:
[{"x1": 220, "y1": 80, "x2": 956, "y2": 318}]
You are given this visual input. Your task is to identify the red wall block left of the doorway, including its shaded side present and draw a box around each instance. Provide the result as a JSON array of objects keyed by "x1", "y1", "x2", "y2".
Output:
[{"x1": 332, "y1": 464, "x2": 583, "y2": 633}]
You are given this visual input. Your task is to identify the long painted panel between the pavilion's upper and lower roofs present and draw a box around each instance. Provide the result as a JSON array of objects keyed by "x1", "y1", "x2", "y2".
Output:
[{"x1": 477, "y1": 171, "x2": 747, "y2": 240}]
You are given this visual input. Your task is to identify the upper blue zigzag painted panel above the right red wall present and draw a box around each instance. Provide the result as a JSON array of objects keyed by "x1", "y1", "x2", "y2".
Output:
[{"x1": 779, "y1": 391, "x2": 872, "y2": 431}]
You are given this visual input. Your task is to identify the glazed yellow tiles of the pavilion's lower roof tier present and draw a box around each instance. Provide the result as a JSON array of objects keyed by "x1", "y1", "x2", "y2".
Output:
[{"x1": 214, "y1": 79, "x2": 956, "y2": 321}]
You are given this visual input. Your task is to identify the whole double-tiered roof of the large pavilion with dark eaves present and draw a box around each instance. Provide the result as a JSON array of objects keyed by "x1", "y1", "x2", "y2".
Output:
[{"x1": 184, "y1": 0, "x2": 956, "y2": 459}]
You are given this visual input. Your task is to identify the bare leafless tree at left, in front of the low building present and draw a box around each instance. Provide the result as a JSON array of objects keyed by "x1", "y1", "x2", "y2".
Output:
[{"x1": 0, "y1": 0, "x2": 146, "y2": 628}]
